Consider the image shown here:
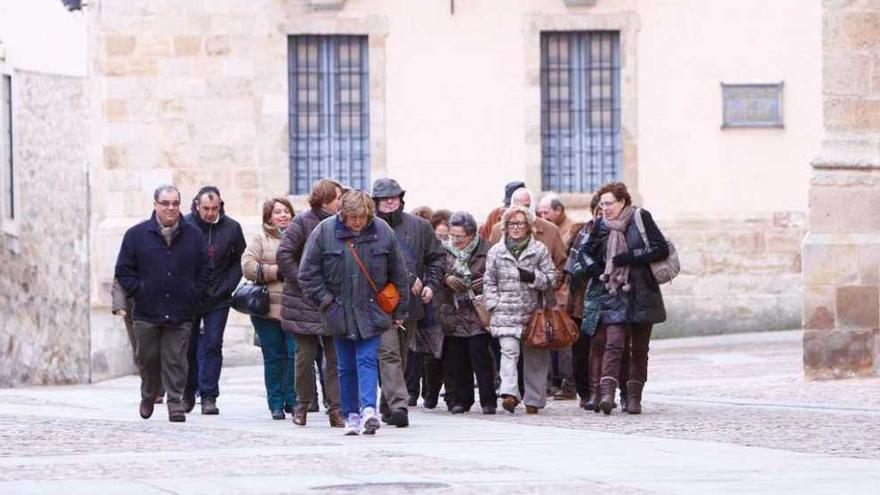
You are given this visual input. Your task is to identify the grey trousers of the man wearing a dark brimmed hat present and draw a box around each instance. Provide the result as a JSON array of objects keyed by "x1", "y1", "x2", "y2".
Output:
[{"x1": 379, "y1": 320, "x2": 418, "y2": 411}]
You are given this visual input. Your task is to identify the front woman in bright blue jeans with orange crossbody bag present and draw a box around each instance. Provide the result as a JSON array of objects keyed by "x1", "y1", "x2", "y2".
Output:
[{"x1": 297, "y1": 190, "x2": 411, "y2": 435}]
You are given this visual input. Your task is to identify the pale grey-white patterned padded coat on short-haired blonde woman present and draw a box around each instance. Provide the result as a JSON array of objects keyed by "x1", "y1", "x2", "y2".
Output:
[{"x1": 483, "y1": 237, "x2": 556, "y2": 338}]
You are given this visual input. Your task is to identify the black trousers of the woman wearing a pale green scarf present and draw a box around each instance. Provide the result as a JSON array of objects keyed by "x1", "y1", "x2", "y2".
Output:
[{"x1": 443, "y1": 333, "x2": 498, "y2": 409}]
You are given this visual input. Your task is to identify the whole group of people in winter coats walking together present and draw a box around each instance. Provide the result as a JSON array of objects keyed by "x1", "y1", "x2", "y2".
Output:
[{"x1": 114, "y1": 178, "x2": 669, "y2": 435}]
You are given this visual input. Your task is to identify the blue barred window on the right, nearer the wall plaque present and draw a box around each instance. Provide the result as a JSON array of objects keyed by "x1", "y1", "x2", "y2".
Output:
[{"x1": 541, "y1": 31, "x2": 622, "y2": 192}]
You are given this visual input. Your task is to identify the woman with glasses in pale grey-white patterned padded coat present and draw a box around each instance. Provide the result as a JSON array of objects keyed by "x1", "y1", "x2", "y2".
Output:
[{"x1": 483, "y1": 206, "x2": 556, "y2": 414}]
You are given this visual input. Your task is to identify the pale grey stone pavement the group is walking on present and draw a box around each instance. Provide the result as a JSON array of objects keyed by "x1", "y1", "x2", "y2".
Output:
[{"x1": 0, "y1": 332, "x2": 880, "y2": 495}]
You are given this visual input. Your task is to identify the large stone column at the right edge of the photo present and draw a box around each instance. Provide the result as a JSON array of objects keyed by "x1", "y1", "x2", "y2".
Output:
[{"x1": 803, "y1": 0, "x2": 880, "y2": 379}]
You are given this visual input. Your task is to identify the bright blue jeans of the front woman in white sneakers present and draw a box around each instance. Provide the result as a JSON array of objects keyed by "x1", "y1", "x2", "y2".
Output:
[{"x1": 333, "y1": 335, "x2": 379, "y2": 417}]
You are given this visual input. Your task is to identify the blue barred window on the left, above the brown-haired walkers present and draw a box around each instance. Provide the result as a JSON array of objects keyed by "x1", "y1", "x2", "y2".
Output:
[{"x1": 288, "y1": 35, "x2": 370, "y2": 194}]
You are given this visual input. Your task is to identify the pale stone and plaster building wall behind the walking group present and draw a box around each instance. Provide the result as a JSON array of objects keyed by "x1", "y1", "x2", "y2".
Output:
[{"x1": 0, "y1": 0, "x2": 822, "y2": 383}]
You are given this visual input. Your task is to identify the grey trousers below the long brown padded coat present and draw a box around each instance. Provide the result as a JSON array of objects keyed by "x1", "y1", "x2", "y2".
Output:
[{"x1": 293, "y1": 334, "x2": 339, "y2": 411}]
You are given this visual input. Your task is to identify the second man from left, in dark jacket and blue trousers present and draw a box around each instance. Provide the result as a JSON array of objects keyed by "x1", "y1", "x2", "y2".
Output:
[{"x1": 185, "y1": 186, "x2": 247, "y2": 414}]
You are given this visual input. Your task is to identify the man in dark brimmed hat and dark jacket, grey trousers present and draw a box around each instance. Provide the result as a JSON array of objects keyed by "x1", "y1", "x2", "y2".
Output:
[{"x1": 372, "y1": 179, "x2": 446, "y2": 427}]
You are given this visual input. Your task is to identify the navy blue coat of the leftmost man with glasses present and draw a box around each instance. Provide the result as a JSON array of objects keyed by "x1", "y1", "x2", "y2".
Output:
[{"x1": 115, "y1": 213, "x2": 210, "y2": 324}]
